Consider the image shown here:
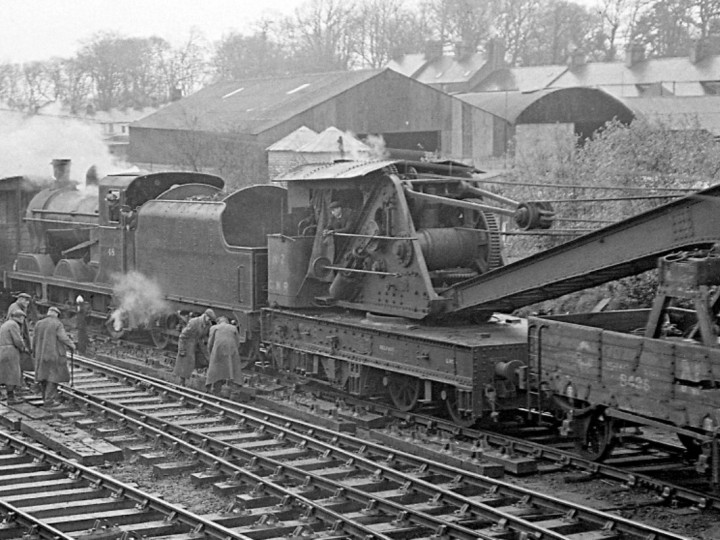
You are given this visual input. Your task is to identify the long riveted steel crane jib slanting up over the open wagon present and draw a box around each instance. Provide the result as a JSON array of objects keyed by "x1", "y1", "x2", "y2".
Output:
[{"x1": 441, "y1": 185, "x2": 720, "y2": 313}]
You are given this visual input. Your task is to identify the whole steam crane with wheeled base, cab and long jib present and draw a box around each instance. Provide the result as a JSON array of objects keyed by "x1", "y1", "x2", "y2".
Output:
[{"x1": 262, "y1": 161, "x2": 720, "y2": 424}]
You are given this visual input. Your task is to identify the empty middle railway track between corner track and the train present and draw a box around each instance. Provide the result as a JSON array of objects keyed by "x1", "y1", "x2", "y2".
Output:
[{"x1": 2, "y1": 354, "x2": 700, "y2": 540}]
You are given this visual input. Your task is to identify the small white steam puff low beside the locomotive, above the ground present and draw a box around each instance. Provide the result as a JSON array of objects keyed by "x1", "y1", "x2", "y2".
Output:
[{"x1": 110, "y1": 271, "x2": 171, "y2": 331}]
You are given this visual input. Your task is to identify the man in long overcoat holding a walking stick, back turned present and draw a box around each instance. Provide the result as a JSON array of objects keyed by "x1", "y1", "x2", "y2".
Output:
[{"x1": 33, "y1": 306, "x2": 75, "y2": 408}]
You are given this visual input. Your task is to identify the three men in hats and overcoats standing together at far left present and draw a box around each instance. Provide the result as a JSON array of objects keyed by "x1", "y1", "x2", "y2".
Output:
[{"x1": 0, "y1": 293, "x2": 76, "y2": 408}]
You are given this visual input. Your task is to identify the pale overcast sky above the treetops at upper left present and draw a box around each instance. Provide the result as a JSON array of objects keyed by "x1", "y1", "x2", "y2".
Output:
[{"x1": 0, "y1": 0, "x2": 304, "y2": 62}]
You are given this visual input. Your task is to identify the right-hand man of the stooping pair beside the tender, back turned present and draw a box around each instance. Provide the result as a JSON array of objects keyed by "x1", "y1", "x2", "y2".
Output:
[{"x1": 205, "y1": 317, "x2": 241, "y2": 394}]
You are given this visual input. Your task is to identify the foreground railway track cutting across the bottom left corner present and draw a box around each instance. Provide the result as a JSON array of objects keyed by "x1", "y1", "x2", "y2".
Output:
[{"x1": 0, "y1": 432, "x2": 253, "y2": 540}]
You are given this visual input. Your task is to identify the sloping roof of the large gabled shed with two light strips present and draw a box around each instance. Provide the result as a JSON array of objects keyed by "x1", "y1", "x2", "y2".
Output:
[{"x1": 132, "y1": 70, "x2": 382, "y2": 135}]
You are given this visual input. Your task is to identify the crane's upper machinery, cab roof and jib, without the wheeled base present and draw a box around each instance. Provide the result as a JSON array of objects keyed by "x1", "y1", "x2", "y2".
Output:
[{"x1": 271, "y1": 162, "x2": 720, "y2": 319}]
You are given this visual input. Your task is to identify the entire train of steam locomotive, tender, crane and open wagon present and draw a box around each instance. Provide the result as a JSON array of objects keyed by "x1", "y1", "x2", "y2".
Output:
[{"x1": 5, "y1": 160, "x2": 720, "y2": 472}]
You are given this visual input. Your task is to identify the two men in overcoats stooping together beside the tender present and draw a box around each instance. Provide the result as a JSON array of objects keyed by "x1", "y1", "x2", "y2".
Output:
[{"x1": 173, "y1": 309, "x2": 242, "y2": 394}]
